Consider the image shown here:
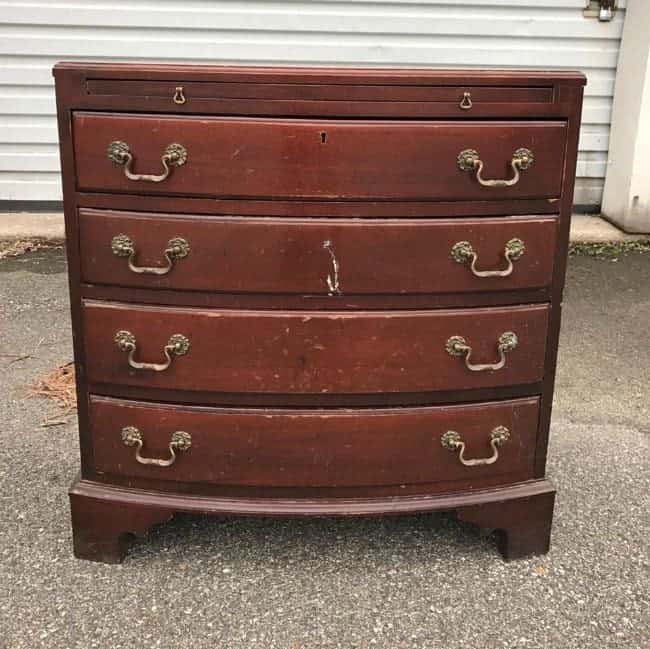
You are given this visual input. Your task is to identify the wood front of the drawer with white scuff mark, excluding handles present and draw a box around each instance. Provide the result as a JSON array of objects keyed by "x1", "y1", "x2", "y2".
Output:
[{"x1": 79, "y1": 209, "x2": 557, "y2": 295}]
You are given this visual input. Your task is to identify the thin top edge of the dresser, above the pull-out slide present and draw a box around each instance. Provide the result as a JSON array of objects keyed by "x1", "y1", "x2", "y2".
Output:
[{"x1": 53, "y1": 62, "x2": 586, "y2": 86}]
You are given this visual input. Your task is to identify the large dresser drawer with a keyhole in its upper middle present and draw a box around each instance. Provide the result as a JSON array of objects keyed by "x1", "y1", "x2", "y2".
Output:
[{"x1": 73, "y1": 112, "x2": 566, "y2": 200}]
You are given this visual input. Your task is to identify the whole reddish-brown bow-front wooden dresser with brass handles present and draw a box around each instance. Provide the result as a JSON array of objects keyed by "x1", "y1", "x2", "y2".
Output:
[{"x1": 54, "y1": 63, "x2": 584, "y2": 562}]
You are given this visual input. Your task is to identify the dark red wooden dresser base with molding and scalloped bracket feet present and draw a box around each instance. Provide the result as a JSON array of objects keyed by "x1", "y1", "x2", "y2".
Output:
[{"x1": 69, "y1": 478, "x2": 555, "y2": 563}]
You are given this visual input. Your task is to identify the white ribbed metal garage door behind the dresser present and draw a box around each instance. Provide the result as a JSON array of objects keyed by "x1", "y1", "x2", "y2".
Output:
[{"x1": 0, "y1": 0, "x2": 625, "y2": 205}]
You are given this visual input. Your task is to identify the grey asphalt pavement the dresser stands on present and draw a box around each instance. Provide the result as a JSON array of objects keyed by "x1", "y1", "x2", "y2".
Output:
[{"x1": 0, "y1": 250, "x2": 650, "y2": 649}]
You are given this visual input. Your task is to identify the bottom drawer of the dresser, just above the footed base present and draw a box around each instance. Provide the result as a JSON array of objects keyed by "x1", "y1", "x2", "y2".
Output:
[{"x1": 90, "y1": 397, "x2": 539, "y2": 489}]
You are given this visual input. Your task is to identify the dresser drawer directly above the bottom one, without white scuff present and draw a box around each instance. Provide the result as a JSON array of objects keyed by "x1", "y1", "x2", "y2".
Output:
[{"x1": 83, "y1": 301, "x2": 549, "y2": 394}]
